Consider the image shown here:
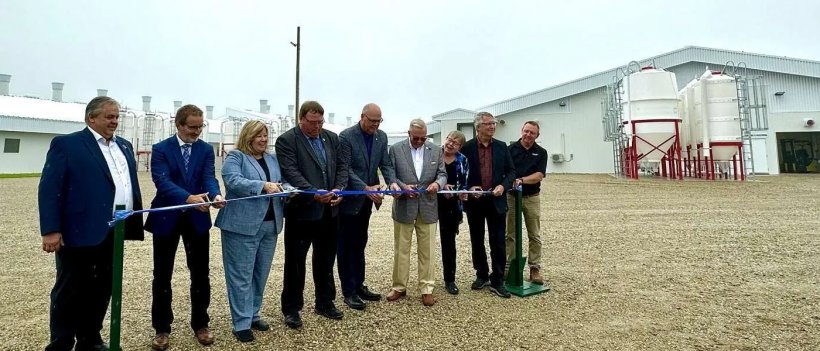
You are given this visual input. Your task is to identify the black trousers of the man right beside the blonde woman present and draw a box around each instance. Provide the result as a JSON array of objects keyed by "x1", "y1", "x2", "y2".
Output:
[{"x1": 282, "y1": 207, "x2": 339, "y2": 315}]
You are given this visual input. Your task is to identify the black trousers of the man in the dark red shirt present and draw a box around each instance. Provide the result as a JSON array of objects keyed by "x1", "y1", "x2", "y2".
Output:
[{"x1": 467, "y1": 196, "x2": 507, "y2": 285}]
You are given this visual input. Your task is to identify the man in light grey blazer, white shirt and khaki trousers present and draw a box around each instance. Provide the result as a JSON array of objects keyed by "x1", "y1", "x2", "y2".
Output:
[{"x1": 387, "y1": 119, "x2": 447, "y2": 306}]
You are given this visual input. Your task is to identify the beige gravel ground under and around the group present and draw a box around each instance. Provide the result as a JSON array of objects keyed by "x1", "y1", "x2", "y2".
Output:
[{"x1": 0, "y1": 173, "x2": 820, "y2": 350}]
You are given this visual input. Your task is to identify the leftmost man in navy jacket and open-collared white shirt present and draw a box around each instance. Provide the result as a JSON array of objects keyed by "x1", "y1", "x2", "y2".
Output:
[{"x1": 38, "y1": 96, "x2": 143, "y2": 351}]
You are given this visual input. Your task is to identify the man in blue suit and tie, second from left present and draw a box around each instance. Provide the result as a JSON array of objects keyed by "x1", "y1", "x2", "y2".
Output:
[{"x1": 145, "y1": 105, "x2": 224, "y2": 350}]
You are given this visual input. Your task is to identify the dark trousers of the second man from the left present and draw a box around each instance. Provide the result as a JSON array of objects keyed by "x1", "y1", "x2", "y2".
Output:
[{"x1": 151, "y1": 214, "x2": 211, "y2": 333}]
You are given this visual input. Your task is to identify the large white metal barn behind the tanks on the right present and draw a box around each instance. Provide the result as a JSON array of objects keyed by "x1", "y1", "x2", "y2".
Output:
[{"x1": 428, "y1": 46, "x2": 820, "y2": 174}]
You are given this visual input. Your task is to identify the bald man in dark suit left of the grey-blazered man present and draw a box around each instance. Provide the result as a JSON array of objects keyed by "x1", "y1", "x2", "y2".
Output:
[{"x1": 337, "y1": 103, "x2": 394, "y2": 310}]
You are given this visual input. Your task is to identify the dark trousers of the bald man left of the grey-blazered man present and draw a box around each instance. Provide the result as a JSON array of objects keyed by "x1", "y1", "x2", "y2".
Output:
[{"x1": 337, "y1": 205, "x2": 373, "y2": 297}]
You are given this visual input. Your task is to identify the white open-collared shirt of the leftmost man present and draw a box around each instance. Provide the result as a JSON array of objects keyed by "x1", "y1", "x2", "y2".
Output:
[{"x1": 88, "y1": 128, "x2": 134, "y2": 213}]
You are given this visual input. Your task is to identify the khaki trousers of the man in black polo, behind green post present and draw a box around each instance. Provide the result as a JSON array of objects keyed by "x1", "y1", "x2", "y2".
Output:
[{"x1": 506, "y1": 194, "x2": 543, "y2": 270}]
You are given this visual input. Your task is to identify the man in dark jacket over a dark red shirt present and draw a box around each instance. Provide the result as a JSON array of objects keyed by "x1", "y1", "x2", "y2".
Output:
[{"x1": 461, "y1": 112, "x2": 515, "y2": 298}]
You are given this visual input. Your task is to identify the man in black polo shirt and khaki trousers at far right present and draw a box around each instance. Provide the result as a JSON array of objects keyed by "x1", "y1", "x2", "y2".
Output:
[{"x1": 506, "y1": 121, "x2": 547, "y2": 284}]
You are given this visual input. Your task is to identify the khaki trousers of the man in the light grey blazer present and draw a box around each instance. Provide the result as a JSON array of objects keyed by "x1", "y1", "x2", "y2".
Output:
[{"x1": 392, "y1": 214, "x2": 436, "y2": 294}]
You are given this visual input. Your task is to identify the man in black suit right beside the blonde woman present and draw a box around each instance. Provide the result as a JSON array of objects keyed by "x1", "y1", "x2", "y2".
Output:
[{"x1": 276, "y1": 101, "x2": 349, "y2": 329}]
